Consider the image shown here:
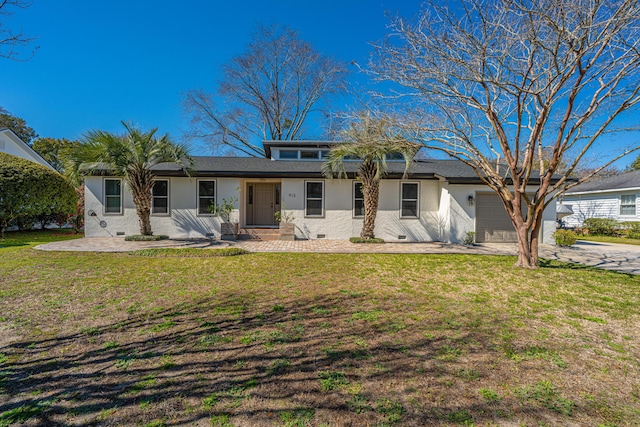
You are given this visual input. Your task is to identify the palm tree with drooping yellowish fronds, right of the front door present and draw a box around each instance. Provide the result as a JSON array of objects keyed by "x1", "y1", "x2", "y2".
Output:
[{"x1": 322, "y1": 113, "x2": 420, "y2": 239}]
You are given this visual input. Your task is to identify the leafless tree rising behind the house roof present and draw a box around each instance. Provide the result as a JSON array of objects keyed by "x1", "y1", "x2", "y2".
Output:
[{"x1": 185, "y1": 26, "x2": 346, "y2": 156}]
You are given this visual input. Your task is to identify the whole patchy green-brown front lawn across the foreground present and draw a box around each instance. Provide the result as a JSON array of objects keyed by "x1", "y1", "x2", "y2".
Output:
[{"x1": 0, "y1": 232, "x2": 640, "y2": 426}]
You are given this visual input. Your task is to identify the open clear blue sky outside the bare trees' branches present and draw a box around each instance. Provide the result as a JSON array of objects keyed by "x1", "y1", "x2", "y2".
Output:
[{"x1": 0, "y1": 0, "x2": 419, "y2": 147}]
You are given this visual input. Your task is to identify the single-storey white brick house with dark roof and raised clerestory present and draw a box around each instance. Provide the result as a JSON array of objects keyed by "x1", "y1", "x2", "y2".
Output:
[{"x1": 85, "y1": 141, "x2": 556, "y2": 243}]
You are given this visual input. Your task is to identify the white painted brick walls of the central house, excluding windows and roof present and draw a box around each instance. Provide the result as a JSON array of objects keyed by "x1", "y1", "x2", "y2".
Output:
[{"x1": 85, "y1": 176, "x2": 555, "y2": 243}]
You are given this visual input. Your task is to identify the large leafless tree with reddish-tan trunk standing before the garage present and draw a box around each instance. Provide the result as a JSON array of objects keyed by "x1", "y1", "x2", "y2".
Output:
[{"x1": 372, "y1": 0, "x2": 640, "y2": 268}]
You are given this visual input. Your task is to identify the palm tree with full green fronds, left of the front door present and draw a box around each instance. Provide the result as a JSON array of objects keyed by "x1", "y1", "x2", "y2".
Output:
[{"x1": 68, "y1": 122, "x2": 193, "y2": 236}]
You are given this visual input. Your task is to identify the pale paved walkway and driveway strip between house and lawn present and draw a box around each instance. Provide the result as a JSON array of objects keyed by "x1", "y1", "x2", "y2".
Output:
[{"x1": 36, "y1": 237, "x2": 640, "y2": 275}]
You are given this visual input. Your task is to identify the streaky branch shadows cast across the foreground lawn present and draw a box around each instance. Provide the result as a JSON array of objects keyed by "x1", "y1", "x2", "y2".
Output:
[{"x1": 0, "y1": 292, "x2": 600, "y2": 426}]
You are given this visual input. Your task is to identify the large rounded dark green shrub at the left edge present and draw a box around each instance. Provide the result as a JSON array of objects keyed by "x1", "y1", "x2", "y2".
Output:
[{"x1": 0, "y1": 153, "x2": 77, "y2": 233}]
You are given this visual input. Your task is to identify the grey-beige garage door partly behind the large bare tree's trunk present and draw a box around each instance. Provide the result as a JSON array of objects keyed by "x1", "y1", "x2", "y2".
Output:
[{"x1": 476, "y1": 193, "x2": 518, "y2": 243}]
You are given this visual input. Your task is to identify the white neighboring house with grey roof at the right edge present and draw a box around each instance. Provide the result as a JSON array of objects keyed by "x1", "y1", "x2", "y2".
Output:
[{"x1": 562, "y1": 171, "x2": 640, "y2": 227}]
